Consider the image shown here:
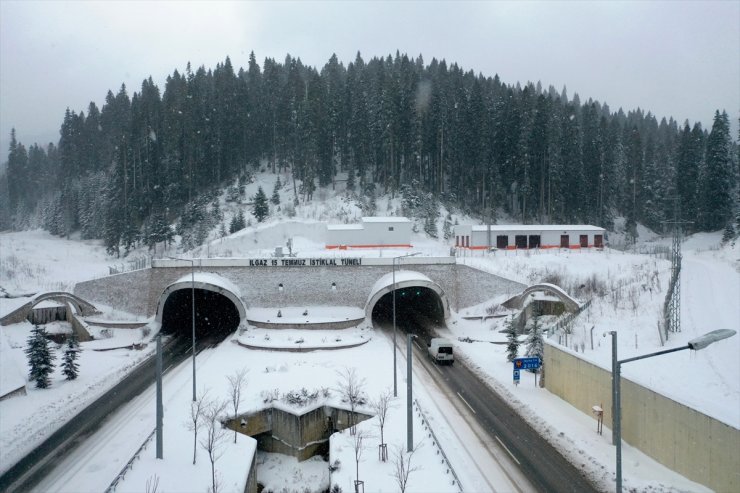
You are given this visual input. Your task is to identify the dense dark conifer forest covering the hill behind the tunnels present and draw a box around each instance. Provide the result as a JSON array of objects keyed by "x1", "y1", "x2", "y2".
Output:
[{"x1": 0, "y1": 53, "x2": 738, "y2": 253}]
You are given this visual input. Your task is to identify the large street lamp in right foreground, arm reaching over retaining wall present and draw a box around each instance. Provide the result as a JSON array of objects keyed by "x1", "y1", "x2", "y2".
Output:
[{"x1": 604, "y1": 329, "x2": 736, "y2": 493}]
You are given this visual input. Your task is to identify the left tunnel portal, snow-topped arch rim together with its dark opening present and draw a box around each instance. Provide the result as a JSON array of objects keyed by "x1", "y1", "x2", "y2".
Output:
[{"x1": 156, "y1": 273, "x2": 247, "y2": 337}]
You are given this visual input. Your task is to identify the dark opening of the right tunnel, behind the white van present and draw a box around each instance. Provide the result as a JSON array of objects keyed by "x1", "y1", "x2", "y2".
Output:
[{"x1": 372, "y1": 286, "x2": 444, "y2": 342}]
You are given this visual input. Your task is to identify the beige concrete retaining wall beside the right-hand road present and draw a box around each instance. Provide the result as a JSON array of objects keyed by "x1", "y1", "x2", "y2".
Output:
[{"x1": 544, "y1": 343, "x2": 740, "y2": 492}]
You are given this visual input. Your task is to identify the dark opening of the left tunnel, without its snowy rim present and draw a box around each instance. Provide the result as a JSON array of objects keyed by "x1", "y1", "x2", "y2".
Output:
[{"x1": 162, "y1": 288, "x2": 240, "y2": 340}]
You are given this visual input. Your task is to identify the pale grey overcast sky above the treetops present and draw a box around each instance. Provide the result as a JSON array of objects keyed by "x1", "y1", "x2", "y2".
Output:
[{"x1": 0, "y1": 0, "x2": 740, "y2": 161}]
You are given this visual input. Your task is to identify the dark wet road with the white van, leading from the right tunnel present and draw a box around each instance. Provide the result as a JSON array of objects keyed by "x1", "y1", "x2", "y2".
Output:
[{"x1": 399, "y1": 316, "x2": 598, "y2": 492}]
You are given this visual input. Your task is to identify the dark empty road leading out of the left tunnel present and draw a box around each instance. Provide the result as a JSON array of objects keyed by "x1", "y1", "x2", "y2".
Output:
[{"x1": 0, "y1": 338, "x2": 191, "y2": 493}]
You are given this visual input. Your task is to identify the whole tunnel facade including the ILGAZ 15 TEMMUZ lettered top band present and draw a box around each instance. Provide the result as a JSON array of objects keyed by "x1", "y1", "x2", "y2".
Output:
[{"x1": 75, "y1": 257, "x2": 524, "y2": 334}]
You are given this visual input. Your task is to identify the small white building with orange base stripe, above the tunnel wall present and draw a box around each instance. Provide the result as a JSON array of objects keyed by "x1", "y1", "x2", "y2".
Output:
[{"x1": 326, "y1": 217, "x2": 411, "y2": 250}]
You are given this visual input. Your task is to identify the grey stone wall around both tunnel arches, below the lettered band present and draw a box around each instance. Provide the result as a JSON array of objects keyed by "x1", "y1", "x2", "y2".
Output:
[{"x1": 74, "y1": 257, "x2": 526, "y2": 316}]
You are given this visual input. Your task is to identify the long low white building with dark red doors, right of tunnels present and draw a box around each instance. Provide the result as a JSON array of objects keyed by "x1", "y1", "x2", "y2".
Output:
[{"x1": 455, "y1": 224, "x2": 606, "y2": 250}]
